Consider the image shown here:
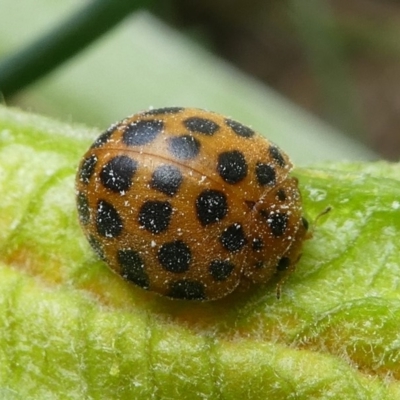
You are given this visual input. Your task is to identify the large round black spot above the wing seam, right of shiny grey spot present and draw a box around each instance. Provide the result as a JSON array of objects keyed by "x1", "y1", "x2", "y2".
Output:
[{"x1": 217, "y1": 150, "x2": 247, "y2": 184}]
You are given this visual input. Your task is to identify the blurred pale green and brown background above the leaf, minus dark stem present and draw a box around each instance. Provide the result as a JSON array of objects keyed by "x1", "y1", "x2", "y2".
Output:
[{"x1": 0, "y1": 0, "x2": 400, "y2": 165}]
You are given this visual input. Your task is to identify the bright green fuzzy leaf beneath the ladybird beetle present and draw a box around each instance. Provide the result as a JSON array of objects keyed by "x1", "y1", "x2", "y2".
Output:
[{"x1": 0, "y1": 104, "x2": 400, "y2": 400}]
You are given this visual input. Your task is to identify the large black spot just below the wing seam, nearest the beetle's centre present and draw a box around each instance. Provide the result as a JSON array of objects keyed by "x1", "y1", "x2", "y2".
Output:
[{"x1": 196, "y1": 189, "x2": 228, "y2": 226}]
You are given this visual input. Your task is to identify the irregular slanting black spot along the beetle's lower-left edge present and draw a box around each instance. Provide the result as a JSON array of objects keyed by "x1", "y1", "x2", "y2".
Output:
[{"x1": 117, "y1": 249, "x2": 150, "y2": 289}]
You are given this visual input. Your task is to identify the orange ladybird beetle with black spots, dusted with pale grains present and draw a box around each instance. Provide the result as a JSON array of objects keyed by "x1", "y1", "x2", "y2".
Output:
[{"x1": 76, "y1": 107, "x2": 308, "y2": 300}]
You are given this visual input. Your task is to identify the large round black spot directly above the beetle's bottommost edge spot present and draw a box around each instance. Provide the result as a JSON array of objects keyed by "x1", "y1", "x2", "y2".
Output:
[{"x1": 157, "y1": 240, "x2": 192, "y2": 273}]
